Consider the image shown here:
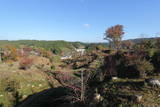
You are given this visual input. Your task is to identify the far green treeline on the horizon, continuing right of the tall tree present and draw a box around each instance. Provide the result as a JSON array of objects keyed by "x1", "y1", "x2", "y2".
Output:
[{"x1": 0, "y1": 38, "x2": 159, "y2": 54}]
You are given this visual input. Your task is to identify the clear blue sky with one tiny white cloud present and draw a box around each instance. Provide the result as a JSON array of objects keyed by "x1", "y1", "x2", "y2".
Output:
[{"x1": 0, "y1": 0, "x2": 160, "y2": 42}]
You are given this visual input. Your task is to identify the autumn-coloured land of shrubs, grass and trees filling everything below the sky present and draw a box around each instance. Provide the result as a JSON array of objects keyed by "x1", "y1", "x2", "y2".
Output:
[{"x1": 0, "y1": 25, "x2": 160, "y2": 107}]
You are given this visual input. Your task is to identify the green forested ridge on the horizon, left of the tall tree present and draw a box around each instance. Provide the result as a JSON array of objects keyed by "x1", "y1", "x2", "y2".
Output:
[{"x1": 0, "y1": 40, "x2": 86, "y2": 54}]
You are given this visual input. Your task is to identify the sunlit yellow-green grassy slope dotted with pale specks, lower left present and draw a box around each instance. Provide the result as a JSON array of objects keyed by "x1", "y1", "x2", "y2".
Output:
[{"x1": 0, "y1": 63, "x2": 49, "y2": 104}]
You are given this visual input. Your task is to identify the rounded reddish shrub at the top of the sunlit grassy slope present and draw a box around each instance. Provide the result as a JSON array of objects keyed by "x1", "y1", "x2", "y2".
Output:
[{"x1": 19, "y1": 57, "x2": 33, "y2": 69}]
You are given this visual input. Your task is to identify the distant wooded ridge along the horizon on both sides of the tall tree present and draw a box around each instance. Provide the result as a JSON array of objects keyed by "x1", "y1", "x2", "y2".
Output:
[{"x1": 0, "y1": 37, "x2": 160, "y2": 51}]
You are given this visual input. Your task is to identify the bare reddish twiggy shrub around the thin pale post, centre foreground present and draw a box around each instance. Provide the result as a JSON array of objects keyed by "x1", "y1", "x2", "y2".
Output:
[{"x1": 46, "y1": 71, "x2": 94, "y2": 104}]
